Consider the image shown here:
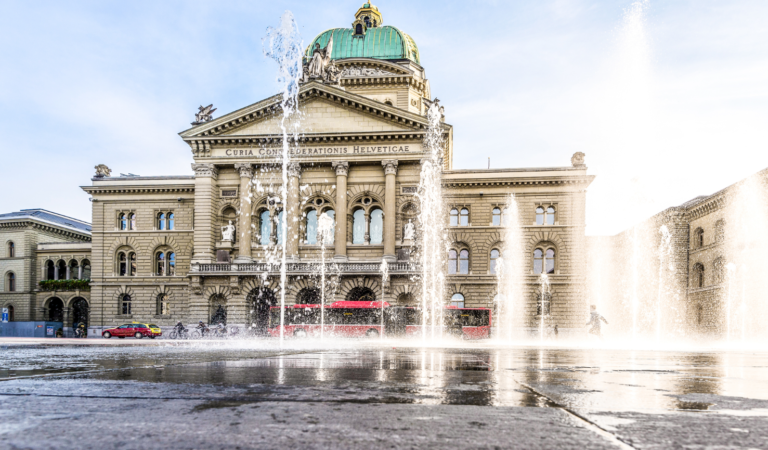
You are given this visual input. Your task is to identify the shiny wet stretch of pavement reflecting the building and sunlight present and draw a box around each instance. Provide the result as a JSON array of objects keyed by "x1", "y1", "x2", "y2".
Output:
[{"x1": 0, "y1": 346, "x2": 768, "y2": 412}]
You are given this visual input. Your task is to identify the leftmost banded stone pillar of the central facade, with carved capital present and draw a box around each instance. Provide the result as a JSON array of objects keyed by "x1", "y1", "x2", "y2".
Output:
[{"x1": 192, "y1": 164, "x2": 219, "y2": 264}]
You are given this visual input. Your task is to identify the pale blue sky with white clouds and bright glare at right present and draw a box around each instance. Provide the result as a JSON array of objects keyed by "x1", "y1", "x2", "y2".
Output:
[{"x1": 0, "y1": 0, "x2": 768, "y2": 235}]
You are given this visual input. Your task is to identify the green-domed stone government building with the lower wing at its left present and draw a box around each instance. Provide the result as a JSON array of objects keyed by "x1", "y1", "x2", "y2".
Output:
[{"x1": 0, "y1": 3, "x2": 593, "y2": 336}]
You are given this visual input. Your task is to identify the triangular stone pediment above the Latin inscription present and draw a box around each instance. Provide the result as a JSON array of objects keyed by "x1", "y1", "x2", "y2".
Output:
[{"x1": 180, "y1": 82, "x2": 427, "y2": 139}]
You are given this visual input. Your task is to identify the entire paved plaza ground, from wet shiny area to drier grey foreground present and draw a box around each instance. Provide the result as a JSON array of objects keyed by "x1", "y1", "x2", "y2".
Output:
[{"x1": 0, "y1": 341, "x2": 768, "y2": 449}]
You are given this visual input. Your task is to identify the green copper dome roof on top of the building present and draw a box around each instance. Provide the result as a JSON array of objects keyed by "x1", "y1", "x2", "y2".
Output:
[{"x1": 305, "y1": 25, "x2": 421, "y2": 65}]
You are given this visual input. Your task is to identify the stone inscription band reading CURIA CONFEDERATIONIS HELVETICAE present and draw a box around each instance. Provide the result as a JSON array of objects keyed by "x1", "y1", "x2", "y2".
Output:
[{"x1": 212, "y1": 142, "x2": 423, "y2": 158}]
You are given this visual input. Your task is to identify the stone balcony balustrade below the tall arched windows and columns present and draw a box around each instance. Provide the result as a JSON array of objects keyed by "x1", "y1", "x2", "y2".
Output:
[{"x1": 191, "y1": 262, "x2": 421, "y2": 275}]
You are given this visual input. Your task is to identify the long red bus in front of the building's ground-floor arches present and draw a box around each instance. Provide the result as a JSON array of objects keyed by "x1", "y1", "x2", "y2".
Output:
[{"x1": 269, "y1": 301, "x2": 491, "y2": 339}]
